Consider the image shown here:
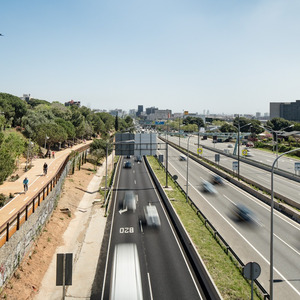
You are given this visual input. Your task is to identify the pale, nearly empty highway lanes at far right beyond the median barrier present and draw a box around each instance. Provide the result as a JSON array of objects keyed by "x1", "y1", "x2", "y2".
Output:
[{"x1": 168, "y1": 136, "x2": 300, "y2": 204}]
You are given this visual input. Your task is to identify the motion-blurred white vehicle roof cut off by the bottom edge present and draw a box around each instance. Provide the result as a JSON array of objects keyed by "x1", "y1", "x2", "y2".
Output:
[{"x1": 109, "y1": 243, "x2": 143, "y2": 300}]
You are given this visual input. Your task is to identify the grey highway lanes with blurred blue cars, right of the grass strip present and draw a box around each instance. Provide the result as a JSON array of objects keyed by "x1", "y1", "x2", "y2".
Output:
[{"x1": 159, "y1": 147, "x2": 300, "y2": 299}]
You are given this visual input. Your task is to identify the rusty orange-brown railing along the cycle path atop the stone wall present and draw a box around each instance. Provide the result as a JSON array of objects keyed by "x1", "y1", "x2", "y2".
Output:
[{"x1": 0, "y1": 145, "x2": 90, "y2": 248}]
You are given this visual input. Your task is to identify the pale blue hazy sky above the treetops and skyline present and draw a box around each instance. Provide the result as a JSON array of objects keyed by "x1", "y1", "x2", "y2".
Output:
[{"x1": 0, "y1": 0, "x2": 300, "y2": 114}]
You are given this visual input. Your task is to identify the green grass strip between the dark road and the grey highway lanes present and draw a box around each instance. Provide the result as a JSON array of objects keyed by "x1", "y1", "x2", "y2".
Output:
[{"x1": 147, "y1": 156, "x2": 262, "y2": 300}]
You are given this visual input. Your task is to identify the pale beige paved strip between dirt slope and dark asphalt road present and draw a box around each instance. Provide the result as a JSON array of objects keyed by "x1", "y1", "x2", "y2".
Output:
[{"x1": 34, "y1": 156, "x2": 112, "y2": 300}]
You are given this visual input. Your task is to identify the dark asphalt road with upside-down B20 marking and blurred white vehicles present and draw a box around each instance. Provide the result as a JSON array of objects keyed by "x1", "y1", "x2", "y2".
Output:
[{"x1": 101, "y1": 158, "x2": 204, "y2": 299}]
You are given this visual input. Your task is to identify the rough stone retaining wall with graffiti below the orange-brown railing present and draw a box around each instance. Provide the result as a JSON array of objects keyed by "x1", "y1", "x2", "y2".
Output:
[{"x1": 0, "y1": 162, "x2": 71, "y2": 287}]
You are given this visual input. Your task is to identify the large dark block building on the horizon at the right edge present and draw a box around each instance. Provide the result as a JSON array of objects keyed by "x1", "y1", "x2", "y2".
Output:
[{"x1": 270, "y1": 100, "x2": 300, "y2": 122}]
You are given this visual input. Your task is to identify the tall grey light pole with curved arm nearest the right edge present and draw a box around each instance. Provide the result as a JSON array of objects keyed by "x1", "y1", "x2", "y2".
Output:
[{"x1": 269, "y1": 148, "x2": 300, "y2": 300}]
